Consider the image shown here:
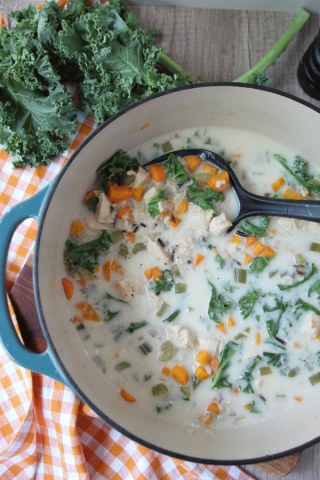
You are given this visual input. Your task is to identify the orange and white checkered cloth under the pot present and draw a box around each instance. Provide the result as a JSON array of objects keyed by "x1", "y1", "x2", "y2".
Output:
[{"x1": 0, "y1": 88, "x2": 252, "y2": 480}]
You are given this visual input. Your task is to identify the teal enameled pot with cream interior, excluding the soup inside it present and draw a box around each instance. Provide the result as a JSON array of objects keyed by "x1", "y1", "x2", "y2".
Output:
[{"x1": 0, "y1": 83, "x2": 320, "y2": 464}]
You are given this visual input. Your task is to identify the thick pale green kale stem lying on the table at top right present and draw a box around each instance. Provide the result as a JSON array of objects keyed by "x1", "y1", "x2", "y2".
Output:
[{"x1": 233, "y1": 7, "x2": 310, "y2": 83}]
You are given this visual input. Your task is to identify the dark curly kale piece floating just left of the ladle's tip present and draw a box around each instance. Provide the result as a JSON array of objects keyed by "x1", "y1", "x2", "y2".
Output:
[{"x1": 97, "y1": 150, "x2": 139, "y2": 191}]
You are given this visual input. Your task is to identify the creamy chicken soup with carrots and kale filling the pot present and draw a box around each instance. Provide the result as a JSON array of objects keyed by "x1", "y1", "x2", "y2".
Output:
[{"x1": 62, "y1": 127, "x2": 320, "y2": 430}]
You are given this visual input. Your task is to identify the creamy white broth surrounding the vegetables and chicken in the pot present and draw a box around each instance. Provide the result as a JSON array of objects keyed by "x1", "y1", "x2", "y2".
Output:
[{"x1": 66, "y1": 127, "x2": 320, "y2": 431}]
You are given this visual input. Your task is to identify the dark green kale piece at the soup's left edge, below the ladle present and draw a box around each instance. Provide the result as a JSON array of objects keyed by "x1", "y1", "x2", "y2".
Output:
[{"x1": 64, "y1": 230, "x2": 112, "y2": 273}]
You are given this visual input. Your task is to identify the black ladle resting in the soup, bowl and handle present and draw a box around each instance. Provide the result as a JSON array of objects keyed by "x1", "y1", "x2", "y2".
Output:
[{"x1": 143, "y1": 148, "x2": 320, "y2": 232}]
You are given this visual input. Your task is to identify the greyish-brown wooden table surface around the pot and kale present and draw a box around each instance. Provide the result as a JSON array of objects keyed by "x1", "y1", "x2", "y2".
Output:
[{"x1": 0, "y1": 0, "x2": 320, "y2": 480}]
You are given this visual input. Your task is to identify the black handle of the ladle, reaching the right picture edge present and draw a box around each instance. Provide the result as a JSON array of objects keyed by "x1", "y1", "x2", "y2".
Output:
[{"x1": 233, "y1": 188, "x2": 320, "y2": 226}]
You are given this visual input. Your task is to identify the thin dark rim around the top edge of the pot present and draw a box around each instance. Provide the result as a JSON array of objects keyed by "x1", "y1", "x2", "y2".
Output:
[{"x1": 33, "y1": 82, "x2": 320, "y2": 465}]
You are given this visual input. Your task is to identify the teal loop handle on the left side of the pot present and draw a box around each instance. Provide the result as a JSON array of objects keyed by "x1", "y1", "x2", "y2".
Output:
[{"x1": 0, "y1": 185, "x2": 70, "y2": 386}]
